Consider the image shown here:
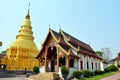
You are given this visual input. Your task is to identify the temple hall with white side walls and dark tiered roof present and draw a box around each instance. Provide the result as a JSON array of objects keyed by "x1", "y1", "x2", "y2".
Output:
[{"x1": 36, "y1": 28, "x2": 102, "y2": 72}]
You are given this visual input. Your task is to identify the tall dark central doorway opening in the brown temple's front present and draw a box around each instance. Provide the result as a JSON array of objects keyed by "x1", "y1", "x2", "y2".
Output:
[{"x1": 47, "y1": 46, "x2": 57, "y2": 72}]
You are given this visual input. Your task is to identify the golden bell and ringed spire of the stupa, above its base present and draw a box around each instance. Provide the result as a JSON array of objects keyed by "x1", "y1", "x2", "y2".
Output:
[{"x1": 11, "y1": 3, "x2": 37, "y2": 50}]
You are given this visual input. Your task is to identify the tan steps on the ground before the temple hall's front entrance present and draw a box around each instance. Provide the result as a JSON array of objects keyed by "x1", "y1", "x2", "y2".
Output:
[{"x1": 29, "y1": 72, "x2": 63, "y2": 80}]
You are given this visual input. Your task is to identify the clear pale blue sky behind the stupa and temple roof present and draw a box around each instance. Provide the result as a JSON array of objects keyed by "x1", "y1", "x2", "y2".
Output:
[{"x1": 0, "y1": 0, "x2": 120, "y2": 57}]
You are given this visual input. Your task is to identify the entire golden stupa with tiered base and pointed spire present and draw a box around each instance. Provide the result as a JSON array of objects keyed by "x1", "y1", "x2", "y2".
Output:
[{"x1": 2, "y1": 9, "x2": 39, "y2": 70}]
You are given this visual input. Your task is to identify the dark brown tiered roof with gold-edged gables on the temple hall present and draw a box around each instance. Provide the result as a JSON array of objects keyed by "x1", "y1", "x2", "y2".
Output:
[{"x1": 36, "y1": 28, "x2": 102, "y2": 59}]
